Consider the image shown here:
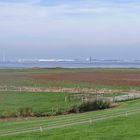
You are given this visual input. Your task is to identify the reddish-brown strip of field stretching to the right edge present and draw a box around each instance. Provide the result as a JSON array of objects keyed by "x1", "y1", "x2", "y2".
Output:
[{"x1": 32, "y1": 71, "x2": 140, "y2": 86}]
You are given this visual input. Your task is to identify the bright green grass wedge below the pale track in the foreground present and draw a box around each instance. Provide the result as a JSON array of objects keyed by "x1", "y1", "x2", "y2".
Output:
[{"x1": 1, "y1": 114, "x2": 140, "y2": 140}]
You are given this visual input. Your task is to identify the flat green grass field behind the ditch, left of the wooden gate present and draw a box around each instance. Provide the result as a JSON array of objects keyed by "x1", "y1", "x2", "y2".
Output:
[{"x1": 0, "y1": 92, "x2": 80, "y2": 117}]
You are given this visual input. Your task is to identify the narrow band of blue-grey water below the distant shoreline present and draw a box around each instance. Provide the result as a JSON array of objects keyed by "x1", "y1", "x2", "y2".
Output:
[{"x1": 0, "y1": 61, "x2": 140, "y2": 69}]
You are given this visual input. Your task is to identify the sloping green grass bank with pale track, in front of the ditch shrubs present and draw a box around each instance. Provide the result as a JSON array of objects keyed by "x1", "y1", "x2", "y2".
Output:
[{"x1": 0, "y1": 100, "x2": 140, "y2": 140}]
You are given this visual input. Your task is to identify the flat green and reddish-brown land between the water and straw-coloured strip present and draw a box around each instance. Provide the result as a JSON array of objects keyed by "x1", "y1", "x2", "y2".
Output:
[{"x1": 0, "y1": 68, "x2": 140, "y2": 89}]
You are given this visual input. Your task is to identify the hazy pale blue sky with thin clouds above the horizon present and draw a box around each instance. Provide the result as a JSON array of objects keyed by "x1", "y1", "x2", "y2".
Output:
[{"x1": 0, "y1": 0, "x2": 140, "y2": 59}]
